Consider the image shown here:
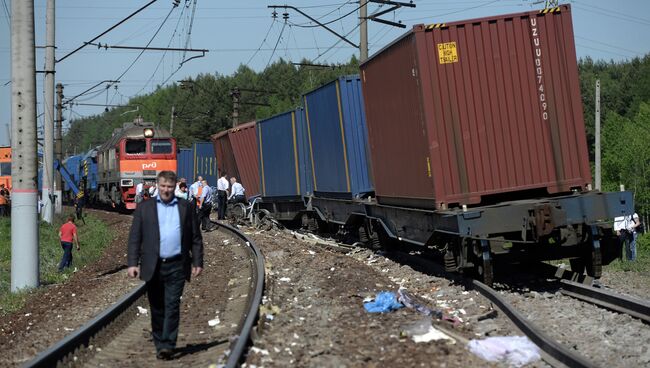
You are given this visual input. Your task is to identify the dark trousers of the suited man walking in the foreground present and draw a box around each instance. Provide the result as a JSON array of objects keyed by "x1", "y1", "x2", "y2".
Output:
[{"x1": 147, "y1": 258, "x2": 185, "y2": 351}]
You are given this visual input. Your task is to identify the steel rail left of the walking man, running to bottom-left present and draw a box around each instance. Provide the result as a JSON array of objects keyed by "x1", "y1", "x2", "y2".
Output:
[{"x1": 23, "y1": 283, "x2": 146, "y2": 368}]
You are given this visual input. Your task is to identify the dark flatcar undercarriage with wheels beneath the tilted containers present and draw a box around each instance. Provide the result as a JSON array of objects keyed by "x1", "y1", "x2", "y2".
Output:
[{"x1": 260, "y1": 191, "x2": 633, "y2": 283}]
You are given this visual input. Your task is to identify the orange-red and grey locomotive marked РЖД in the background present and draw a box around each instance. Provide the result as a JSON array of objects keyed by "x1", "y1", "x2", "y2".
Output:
[{"x1": 97, "y1": 120, "x2": 177, "y2": 210}]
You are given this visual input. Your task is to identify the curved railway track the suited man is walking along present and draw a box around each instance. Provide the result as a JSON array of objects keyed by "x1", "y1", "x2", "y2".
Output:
[{"x1": 25, "y1": 221, "x2": 264, "y2": 367}]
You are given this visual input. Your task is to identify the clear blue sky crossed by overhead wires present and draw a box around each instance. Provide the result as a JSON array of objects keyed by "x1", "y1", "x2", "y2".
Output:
[{"x1": 0, "y1": 0, "x2": 650, "y2": 145}]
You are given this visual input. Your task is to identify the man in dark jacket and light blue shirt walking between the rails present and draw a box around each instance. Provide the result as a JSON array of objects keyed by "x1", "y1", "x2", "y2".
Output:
[{"x1": 127, "y1": 171, "x2": 203, "y2": 360}]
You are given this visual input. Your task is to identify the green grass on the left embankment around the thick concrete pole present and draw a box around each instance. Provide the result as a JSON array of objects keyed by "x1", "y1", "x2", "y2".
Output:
[{"x1": 0, "y1": 214, "x2": 111, "y2": 316}]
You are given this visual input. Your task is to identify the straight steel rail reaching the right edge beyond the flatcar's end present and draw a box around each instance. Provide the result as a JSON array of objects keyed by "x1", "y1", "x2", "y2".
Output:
[{"x1": 560, "y1": 280, "x2": 650, "y2": 323}]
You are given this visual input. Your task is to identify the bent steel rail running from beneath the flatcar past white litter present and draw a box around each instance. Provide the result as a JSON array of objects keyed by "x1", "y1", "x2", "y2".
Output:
[{"x1": 472, "y1": 280, "x2": 597, "y2": 368}]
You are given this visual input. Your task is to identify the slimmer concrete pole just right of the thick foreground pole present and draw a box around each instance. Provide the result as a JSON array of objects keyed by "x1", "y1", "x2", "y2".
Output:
[{"x1": 41, "y1": 0, "x2": 55, "y2": 224}]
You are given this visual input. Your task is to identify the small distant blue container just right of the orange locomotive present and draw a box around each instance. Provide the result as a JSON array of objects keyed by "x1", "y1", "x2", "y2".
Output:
[{"x1": 176, "y1": 142, "x2": 218, "y2": 186}]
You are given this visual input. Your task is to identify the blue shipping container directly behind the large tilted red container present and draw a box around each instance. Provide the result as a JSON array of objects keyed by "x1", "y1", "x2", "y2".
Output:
[{"x1": 304, "y1": 75, "x2": 373, "y2": 197}]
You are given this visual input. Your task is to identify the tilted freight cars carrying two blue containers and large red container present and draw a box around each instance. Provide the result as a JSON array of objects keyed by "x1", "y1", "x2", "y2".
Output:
[{"x1": 217, "y1": 5, "x2": 633, "y2": 282}]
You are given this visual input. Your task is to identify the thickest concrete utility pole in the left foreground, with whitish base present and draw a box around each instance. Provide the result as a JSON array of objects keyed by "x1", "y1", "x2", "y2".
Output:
[{"x1": 11, "y1": 0, "x2": 38, "y2": 291}]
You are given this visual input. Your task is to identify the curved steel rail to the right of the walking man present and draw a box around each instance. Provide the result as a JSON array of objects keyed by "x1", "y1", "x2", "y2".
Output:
[{"x1": 218, "y1": 222, "x2": 265, "y2": 368}]
